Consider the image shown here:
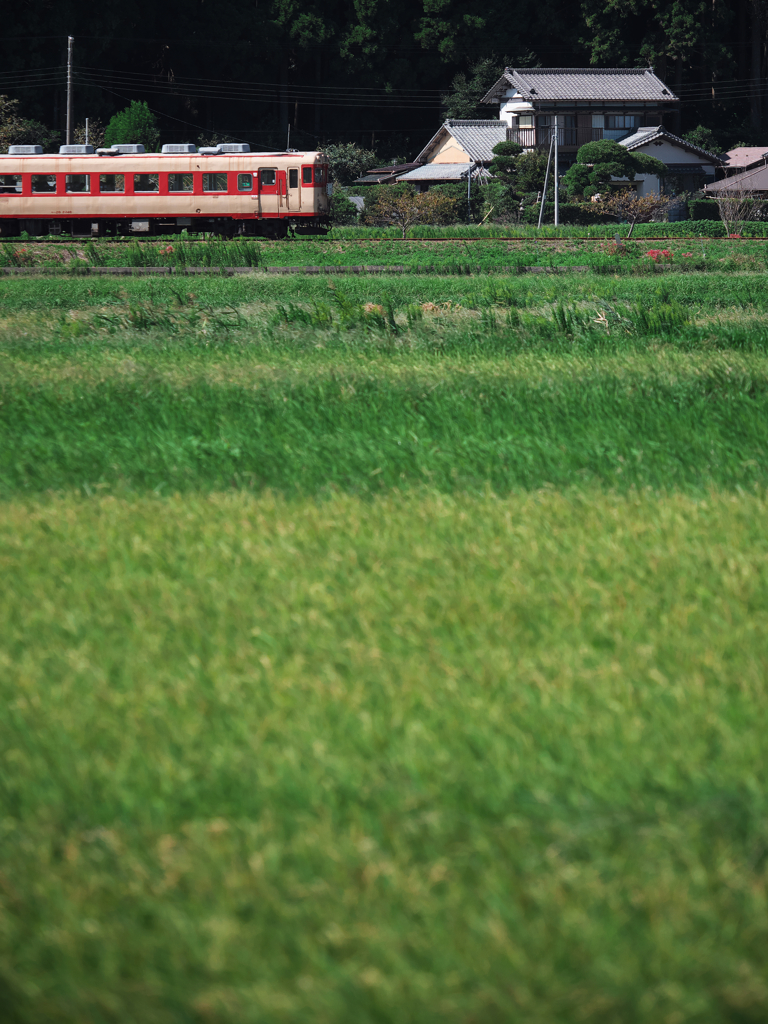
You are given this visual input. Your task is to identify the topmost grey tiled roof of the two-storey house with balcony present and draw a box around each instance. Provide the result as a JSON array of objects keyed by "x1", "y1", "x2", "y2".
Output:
[{"x1": 482, "y1": 68, "x2": 677, "y2": 103}]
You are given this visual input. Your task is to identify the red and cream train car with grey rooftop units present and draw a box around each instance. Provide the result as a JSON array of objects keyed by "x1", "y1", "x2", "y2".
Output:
[{"x1": 0, "y1": 145, "x2": 329, "y2": 238}]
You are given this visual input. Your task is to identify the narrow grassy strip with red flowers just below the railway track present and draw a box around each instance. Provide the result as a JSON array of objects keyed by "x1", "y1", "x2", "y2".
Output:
[{"x1": 0, "y1": 234, "x2": 768, "y2": 275}]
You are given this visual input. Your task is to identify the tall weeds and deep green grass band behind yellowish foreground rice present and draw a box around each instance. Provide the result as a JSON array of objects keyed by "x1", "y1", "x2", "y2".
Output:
[{"x1": 0, "y1": 285, "x2": 768, "y2": 496}]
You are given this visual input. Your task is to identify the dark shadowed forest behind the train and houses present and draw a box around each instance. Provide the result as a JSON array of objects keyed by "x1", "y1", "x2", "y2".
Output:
[{"x1": 0, "y1": 0, "x2": 768, "y2": 160}]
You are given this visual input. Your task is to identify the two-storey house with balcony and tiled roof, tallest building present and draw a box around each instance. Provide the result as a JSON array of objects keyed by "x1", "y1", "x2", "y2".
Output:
[{"x1": 482, "y1": 68, "x2": 679, "y2": 166}]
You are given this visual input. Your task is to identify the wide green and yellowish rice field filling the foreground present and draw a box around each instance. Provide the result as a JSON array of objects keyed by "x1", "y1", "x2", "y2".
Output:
[{"x1": 0, "y1": 268, "x2": 768, "y2": 1024}]
